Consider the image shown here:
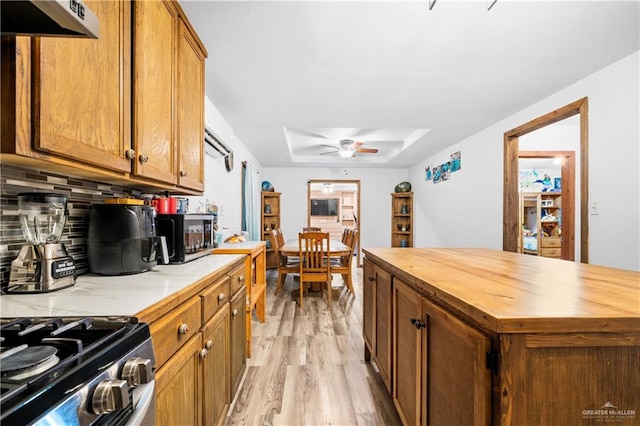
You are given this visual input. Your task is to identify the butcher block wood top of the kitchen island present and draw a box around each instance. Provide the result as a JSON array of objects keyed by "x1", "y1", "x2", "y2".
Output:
[{"x1": 363, "y1": 248, "x2": 640, "y2": 333}]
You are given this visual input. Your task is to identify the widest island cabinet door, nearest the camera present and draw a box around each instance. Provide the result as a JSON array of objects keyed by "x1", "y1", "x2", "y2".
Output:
[{"x1": 423, "y1": 300, "x2": 492, "y2": 425}]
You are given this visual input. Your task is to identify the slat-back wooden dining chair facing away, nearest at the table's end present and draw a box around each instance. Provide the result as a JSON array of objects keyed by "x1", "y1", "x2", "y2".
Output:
[{"x1": 298, "y1": 232, "x2": 331, "y2": 308}]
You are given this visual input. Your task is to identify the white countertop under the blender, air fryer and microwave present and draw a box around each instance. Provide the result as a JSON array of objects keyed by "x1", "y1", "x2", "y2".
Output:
[{"x1": 0, "y1": 254, "x2": 244, "y2": 318}]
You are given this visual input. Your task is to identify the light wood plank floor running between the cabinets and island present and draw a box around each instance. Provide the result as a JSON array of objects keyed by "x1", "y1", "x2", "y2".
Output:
[{"x1": 226, "y1": 262, "x2": 401, "y2": 426}]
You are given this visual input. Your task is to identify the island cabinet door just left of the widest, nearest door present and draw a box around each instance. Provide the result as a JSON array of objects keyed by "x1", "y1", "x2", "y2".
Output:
[{"x1": 393, "y1": 278, "x2": 422, "y2": 425}]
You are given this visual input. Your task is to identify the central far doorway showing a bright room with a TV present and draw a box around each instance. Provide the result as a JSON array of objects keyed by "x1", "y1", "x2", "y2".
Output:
[{"x1": 307, "y1": 179, "x2": 361, "y2": 267}]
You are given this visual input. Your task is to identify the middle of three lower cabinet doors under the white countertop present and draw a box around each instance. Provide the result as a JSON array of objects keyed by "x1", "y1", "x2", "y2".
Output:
[{"x1": 202, "y1": 305, "x2": 231, "y2": 425}]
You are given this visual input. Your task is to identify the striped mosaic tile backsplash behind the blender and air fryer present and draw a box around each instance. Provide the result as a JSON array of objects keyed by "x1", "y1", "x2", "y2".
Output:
[{"x1": 0, "y1": 164, "x2": 146, "y2": 287}]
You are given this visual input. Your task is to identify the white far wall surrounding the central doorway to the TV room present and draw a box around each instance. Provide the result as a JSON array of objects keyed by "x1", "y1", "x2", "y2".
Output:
[{"x1": 261, "y1": 166, "x2": 407, "y2": 253}]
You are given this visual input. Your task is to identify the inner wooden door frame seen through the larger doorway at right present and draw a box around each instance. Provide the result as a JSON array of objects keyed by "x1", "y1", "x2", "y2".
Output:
[{"x1": 518, "y1": 151, "x2": 576, "y2": 260}]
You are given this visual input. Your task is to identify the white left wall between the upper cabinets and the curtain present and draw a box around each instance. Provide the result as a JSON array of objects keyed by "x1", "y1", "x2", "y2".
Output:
[{"x1": 188, "y1": 98, "x2": 262, "y2": 231}]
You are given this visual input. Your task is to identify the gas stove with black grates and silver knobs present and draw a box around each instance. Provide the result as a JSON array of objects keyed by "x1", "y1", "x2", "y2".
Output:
[{"x1": 0, "y1": 318, "x2": 155, "y2": 426}]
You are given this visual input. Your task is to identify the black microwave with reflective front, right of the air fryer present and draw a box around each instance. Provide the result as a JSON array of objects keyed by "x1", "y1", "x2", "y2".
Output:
[{"x1": 156, "y1": 214, "x2": 218, "y2": 263}]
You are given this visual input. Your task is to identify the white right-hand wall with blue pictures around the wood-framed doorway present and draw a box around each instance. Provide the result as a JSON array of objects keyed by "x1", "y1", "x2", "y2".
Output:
[{"x1": 409, "y1": 52, "x2": 640, "y2": 270}]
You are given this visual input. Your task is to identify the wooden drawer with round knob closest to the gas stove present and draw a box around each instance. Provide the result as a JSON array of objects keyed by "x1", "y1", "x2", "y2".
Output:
[{"x1": 149, "y1": 297, "x2": 202, "y2": 368}]
